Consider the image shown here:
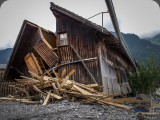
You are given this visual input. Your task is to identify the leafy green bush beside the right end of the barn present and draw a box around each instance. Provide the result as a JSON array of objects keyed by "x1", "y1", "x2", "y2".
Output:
[{"x1": 129, "y1": 57, "x2": 160, "y2": 94}]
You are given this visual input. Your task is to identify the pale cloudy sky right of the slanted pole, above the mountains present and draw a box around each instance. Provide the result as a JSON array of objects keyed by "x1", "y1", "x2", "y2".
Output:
[{"x1": 113, "y1": 0, "x2": 160, "y2": 37}]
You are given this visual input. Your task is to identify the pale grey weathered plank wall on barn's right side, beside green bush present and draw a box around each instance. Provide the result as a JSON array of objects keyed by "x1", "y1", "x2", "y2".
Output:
[{"x1": 99, "y1": 44, "x2": 131, "y2": 94}]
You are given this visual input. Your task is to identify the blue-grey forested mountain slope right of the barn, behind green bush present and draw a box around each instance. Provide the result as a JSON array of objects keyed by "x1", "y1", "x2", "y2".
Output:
[{"x1": 122, "y1": 33, "x2": 160, "y2": 64}]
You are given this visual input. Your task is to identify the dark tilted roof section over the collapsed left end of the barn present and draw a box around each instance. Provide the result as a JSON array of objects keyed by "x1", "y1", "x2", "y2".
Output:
[{"x1": 4, "y1": 20, "x2": 55, "y2": 79}]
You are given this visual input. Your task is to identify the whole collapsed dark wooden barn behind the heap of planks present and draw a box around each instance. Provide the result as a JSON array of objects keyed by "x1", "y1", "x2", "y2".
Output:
[{"x1": 4, "y1": 3, "x2": 135, "y2": 94}]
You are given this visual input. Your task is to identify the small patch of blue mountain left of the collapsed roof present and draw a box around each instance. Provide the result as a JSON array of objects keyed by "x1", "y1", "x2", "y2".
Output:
[{"x1": 0, "y1": 48, "x2": 12, "y2": 64}]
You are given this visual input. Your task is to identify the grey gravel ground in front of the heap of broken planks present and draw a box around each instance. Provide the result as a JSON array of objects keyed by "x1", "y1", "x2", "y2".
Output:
[{"x1": 0, "y1": 100, "x2": 159, "y2": 120}]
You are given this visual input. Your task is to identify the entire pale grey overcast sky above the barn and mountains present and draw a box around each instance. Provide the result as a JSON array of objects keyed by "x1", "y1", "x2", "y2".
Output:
[{"x1": 0, "y1": 0, "x2": 160, "y2": 49}]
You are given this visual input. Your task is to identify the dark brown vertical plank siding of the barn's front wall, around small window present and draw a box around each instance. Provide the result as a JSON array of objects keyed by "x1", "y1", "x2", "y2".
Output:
[{"x1": 56, "y1": 13, "x2": 102, "y2": 84}]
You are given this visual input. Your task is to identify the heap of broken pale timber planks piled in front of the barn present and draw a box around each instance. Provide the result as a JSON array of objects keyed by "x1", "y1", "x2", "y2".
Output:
[{"x1": 0, "y1": 69, "x2": 150, "y2": 110}]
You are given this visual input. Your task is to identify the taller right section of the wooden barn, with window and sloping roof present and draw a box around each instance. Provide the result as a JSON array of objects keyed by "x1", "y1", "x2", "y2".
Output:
[{"x1": 50, "y1": 3, "x2": 135, "y2": 94}]
